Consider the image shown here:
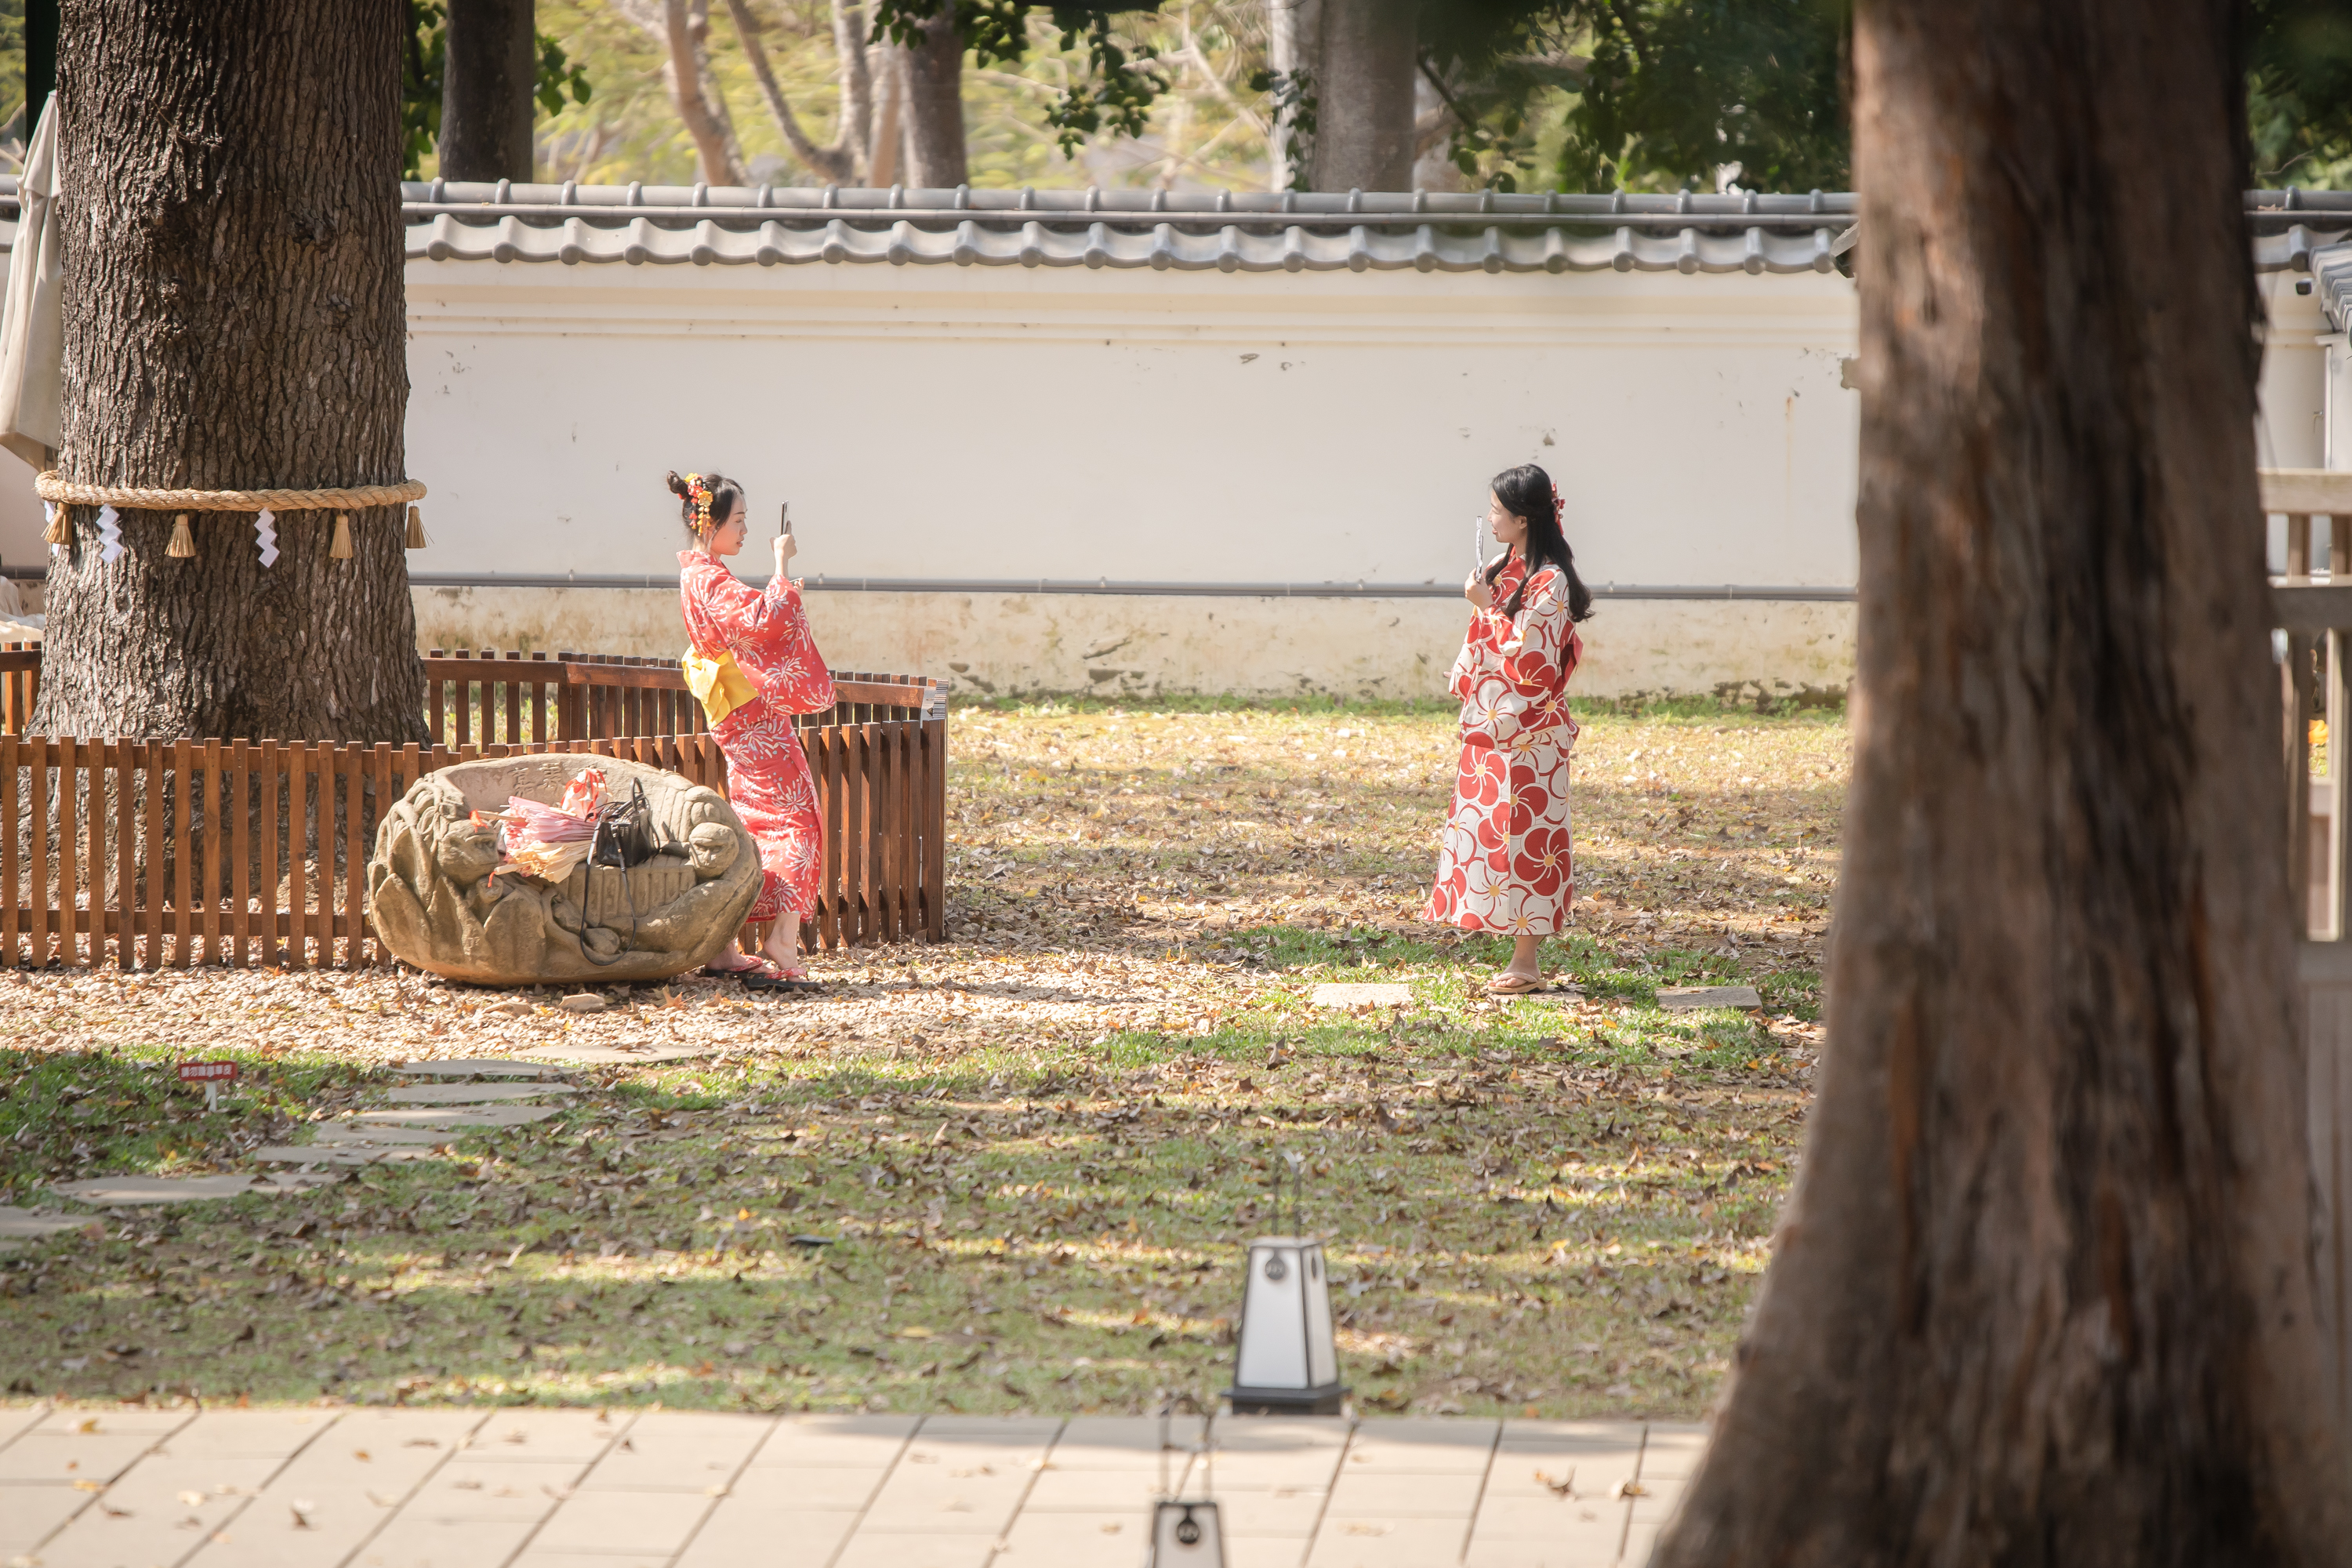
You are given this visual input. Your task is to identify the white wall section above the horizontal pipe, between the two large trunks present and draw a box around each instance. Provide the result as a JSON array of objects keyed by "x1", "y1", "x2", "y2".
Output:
[{"x1": 395, "y1": 261, "x2": 1856, "y2": 586}]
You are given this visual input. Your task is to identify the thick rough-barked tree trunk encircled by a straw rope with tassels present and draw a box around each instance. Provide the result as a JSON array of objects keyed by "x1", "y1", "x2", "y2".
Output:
[{"x1": 35, "y1": 0, "x2": 423, "y2": 741}]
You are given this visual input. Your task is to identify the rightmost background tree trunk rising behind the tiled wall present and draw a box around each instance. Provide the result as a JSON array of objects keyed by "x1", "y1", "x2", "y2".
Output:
[{"x1": 1310, "y1": 0, "x2": 1416, "y2": 191}]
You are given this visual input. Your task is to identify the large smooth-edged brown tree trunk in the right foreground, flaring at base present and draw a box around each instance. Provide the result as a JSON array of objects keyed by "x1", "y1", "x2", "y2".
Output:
[{"x1": 1653, "y1": 0, "x2": 2352, "y2": 1568}]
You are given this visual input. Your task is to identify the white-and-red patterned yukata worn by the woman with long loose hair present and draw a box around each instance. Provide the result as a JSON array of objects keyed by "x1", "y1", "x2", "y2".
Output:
[{"x1": 1421, "y1": 550, "x2": 1585, "y2": 935}]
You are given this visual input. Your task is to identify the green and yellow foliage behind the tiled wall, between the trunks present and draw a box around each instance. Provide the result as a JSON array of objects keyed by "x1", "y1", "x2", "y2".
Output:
[{"x1": 0, "y1": 0, "x2": 2352, "y2": 191}]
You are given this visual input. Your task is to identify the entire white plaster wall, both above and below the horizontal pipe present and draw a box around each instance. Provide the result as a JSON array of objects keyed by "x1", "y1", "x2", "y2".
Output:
[{"x1": 13, "y1": 250, "x2": 2352, "y2": 696}]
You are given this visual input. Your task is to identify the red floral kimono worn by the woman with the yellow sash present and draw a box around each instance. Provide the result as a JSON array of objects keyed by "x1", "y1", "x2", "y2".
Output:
[{"x1": 677, "y1": 550, "x2": 833, "y2": 919}]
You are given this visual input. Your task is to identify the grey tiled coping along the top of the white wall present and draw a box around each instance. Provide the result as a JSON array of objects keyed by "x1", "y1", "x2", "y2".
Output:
[{"x1": 0, "y1": 176, "x2": 2352, "y2": 281}]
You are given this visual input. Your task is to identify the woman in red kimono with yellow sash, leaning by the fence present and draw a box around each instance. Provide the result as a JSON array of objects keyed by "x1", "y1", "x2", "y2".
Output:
[{"x1": 670, "y1": 473, "x2": 833, "y2": 989}]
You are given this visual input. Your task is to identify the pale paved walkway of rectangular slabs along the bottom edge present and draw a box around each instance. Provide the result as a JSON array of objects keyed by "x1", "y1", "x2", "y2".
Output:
[{"x1": 0, "y1": 1406, "x2": 1703, "y2": 1568}]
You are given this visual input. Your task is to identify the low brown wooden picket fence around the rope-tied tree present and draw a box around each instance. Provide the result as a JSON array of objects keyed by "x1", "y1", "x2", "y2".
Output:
[{"x1": 0, "y1": 644, "x2": 948, "y2": 968}]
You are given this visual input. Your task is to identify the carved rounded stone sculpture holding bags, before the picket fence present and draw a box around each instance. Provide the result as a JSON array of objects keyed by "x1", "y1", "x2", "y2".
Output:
[{"x1": 367, "y1": 753, "x2": 760, "y2": 985}]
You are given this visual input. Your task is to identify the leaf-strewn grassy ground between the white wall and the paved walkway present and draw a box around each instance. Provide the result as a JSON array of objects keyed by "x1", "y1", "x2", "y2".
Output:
[{"x1": 0, "y1": 703, "x2": 1849, "y2": 1417}]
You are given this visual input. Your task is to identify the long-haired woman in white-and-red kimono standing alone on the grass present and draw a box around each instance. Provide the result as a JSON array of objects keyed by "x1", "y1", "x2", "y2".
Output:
[{"x1": 1423, "y1": 463, "x2": 1592, "y2": 996}]
